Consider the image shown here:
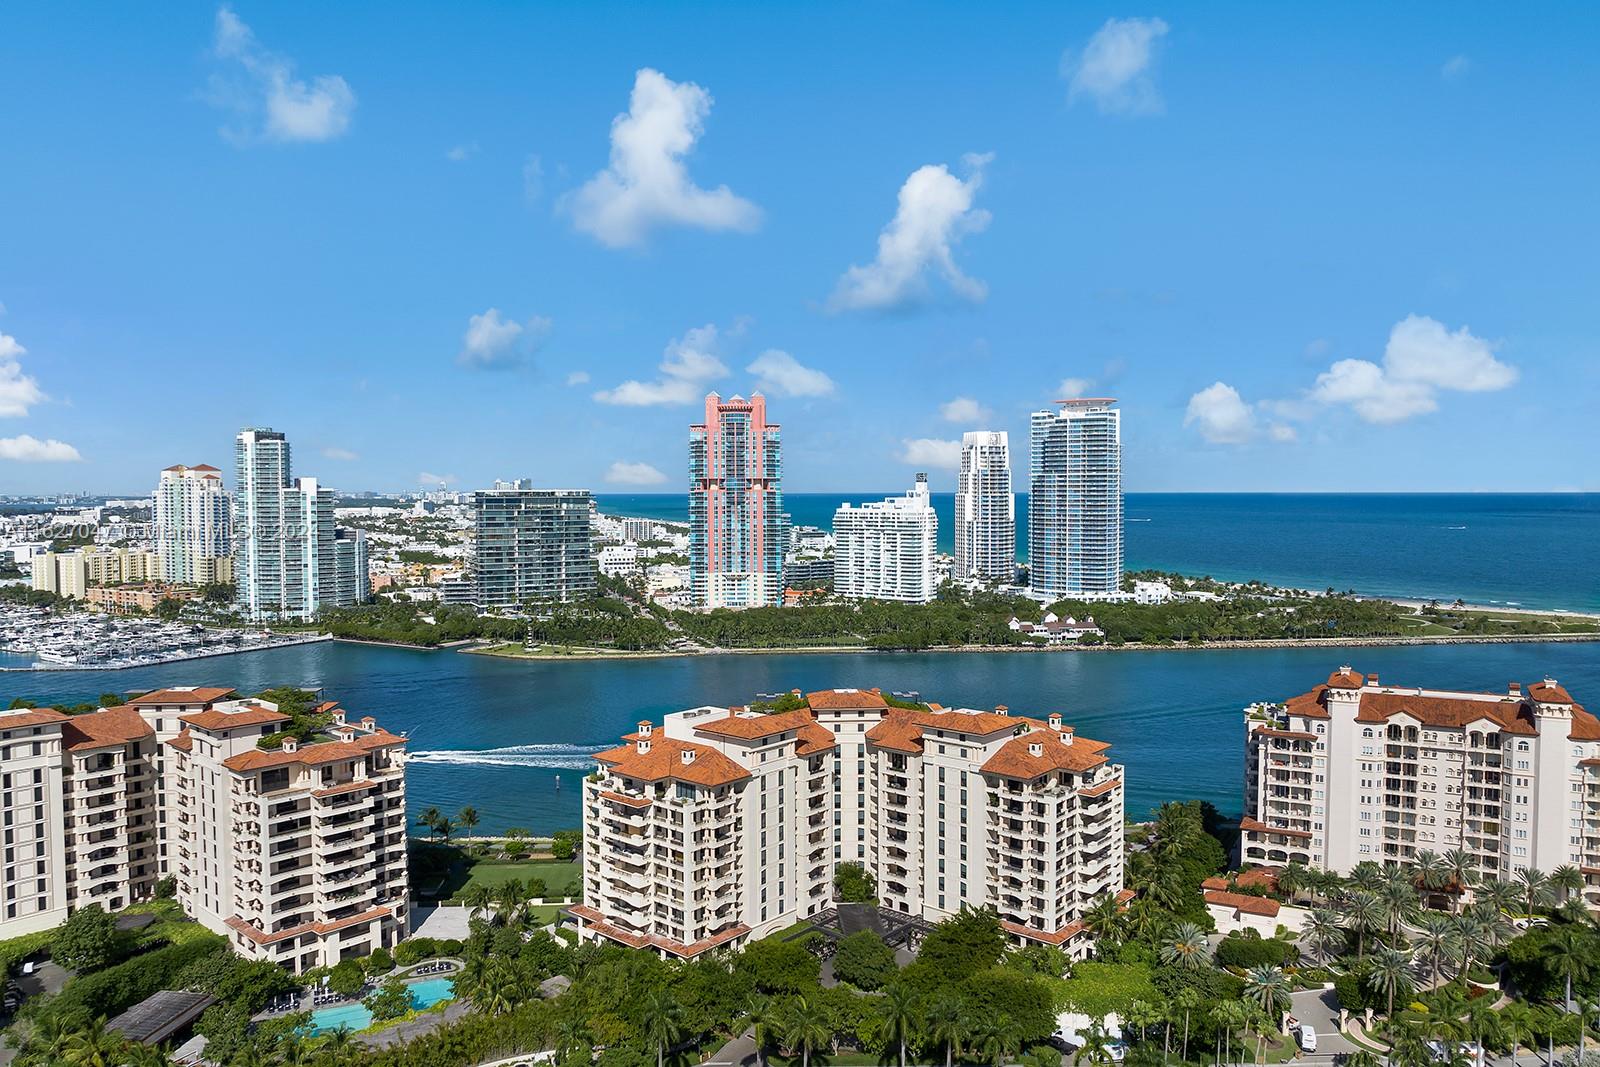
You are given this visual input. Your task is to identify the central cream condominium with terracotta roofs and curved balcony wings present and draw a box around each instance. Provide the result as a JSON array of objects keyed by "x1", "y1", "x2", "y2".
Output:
[{"x1": 571, "y1": 689, "x2": 1123, "y2": 958}]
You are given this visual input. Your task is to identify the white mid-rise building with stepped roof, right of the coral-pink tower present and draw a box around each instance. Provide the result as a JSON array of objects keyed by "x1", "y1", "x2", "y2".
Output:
[{"x1": 834, "y1": 474, "x2": 939, "y2": 603}]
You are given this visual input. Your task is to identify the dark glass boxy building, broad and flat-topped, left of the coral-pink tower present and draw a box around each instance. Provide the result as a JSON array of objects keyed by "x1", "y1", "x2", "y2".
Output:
[{"x1": 472, "y1": 478, "x2": 595, "y2": 609}]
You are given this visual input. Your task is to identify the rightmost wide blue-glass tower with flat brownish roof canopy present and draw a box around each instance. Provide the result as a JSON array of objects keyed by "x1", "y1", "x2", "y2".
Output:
[{"x1": 1027, "y1": 400, "x2": 1122, "y2": 598}]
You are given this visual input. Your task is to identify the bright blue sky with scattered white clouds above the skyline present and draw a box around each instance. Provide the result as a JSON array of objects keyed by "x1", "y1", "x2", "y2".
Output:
[{"x1": 0, "y1": 2, "x2": 1600, "y2": 493}]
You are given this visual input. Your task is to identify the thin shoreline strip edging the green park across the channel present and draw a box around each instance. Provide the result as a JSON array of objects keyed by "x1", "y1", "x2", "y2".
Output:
[{"x1": 458, "y1": 632, "x2": 1600, "y2": 662}]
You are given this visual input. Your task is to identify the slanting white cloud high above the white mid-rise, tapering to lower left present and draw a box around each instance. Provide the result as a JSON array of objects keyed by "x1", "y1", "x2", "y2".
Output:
[{"x1": 829, "y1": 154, "x2": 994, "y2": 310}]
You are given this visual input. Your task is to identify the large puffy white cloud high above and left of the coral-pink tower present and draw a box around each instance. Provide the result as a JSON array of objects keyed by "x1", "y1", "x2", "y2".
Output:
[{"x1": 566, "y1": 67, "x2": 762, "y2": 248}]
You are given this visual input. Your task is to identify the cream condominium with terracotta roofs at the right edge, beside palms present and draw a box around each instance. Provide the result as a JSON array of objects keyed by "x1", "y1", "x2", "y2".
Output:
[{"x1": 1242, "y1": 667, "x2": 1600, "y2": 902}]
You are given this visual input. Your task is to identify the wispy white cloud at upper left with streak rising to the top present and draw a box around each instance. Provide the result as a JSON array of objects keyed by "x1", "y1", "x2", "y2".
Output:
[{"x1": 213, "y1": 6, "x2": 355, "y2": 144}]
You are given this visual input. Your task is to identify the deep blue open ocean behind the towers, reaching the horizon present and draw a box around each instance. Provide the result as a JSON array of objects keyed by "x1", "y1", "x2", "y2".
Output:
[{"x1": 597, "y1": 493, "x2": 1600, "y2": 611}]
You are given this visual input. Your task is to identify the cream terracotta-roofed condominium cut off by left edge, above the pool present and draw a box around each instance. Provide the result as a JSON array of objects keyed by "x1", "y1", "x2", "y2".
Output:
[{"x1": 0, "y1": 686, "x2": 408, "y2": 971}]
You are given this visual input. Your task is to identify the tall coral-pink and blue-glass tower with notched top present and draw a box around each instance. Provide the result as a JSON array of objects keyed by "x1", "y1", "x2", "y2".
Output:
[{"x1": 690, "y1": 394, "x2": 789, "y2": 608}]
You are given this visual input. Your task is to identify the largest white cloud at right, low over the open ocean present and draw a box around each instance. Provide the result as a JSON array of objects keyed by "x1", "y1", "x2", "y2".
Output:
[{"x1": 1310, "y1": 315, "x2": 1518, "y2": 424}]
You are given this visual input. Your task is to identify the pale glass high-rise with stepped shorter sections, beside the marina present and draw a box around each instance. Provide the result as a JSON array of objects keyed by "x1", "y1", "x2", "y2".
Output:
[{"x1": 234, "y1": 429, "x2": 370, "y2": 619}]
